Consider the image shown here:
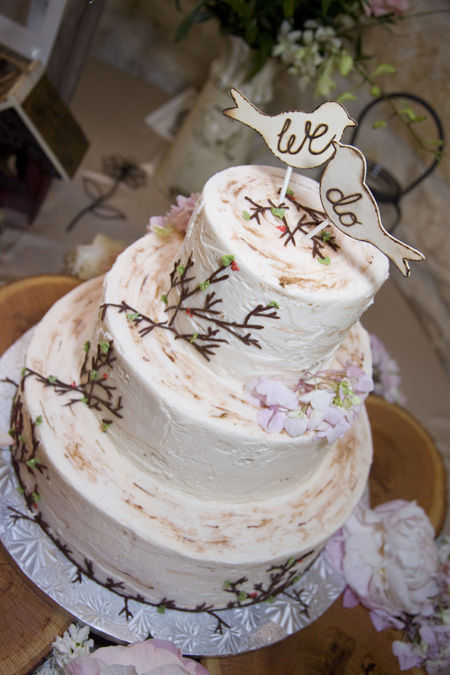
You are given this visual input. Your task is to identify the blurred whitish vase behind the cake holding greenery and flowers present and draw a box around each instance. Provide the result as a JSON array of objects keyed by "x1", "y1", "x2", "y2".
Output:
[{"x1": 155, "y1": 37, "x2": 275, "y2": 197}]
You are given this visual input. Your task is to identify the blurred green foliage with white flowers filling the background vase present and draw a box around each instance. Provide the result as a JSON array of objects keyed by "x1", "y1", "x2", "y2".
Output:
[{"x1": 176, "y1": 0, "x2": 410, "y2": 100}]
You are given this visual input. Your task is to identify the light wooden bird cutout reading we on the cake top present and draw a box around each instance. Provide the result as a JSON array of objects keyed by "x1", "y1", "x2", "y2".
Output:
[{"x1": 223, "y1": 88, "x2": 356, "y2": 169}]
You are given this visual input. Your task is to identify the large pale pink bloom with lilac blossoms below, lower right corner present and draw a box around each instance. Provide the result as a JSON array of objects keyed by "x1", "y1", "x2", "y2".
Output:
[{"x1": 326, "y1": 499, "x2": 450, "y2": 674}]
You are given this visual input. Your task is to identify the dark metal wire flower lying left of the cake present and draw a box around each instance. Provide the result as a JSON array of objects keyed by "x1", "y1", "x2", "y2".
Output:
[{"x1": 66, "y1": 154, "x2": 147, "y2": 232}]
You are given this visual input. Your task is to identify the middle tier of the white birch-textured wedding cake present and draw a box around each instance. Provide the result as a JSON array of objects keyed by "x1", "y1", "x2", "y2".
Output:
[{"x1": 80, "y1": 228, "x2": 371, "y2": 503}]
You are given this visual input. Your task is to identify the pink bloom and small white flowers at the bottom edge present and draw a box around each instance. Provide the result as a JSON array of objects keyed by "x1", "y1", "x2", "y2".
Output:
[{"x1": 36, "y1": 624, "x2": 209, "y2": 675}]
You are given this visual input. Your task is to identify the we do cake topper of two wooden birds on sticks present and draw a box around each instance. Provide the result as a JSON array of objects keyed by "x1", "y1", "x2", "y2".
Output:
[{"x1": 223, "y1": 88, "x2": 424, "y2": 276}]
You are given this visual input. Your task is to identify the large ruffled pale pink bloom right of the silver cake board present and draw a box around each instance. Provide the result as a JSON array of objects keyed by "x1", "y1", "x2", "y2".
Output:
[{"x1": 327, "y1": 499, "x2": 439, "y2": 627}]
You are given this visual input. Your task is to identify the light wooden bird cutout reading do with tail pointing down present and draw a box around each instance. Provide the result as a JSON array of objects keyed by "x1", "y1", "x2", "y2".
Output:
[{"x1": 320, "y1": 141, "x2": 424, "y2": 276}]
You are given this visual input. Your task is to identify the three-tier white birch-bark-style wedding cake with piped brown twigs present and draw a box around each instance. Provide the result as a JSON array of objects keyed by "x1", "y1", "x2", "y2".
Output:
[{"x1": 13, "y1": 166, "x2": 388, "y2": 610}]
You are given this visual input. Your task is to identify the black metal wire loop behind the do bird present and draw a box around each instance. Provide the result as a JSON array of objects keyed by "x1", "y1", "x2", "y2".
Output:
[{"x1": 350, "y1": 92, "x2": 444, "y2": 232}]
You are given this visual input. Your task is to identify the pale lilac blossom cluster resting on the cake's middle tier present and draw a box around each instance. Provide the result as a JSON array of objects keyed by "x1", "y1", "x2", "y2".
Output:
[{"x1": 245, "y1": 361, "x2": 373, "y2": 443}]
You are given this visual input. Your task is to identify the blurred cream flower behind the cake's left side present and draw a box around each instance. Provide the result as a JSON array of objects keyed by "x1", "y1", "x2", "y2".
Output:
[{"x1": 66, "y1": 234, "x2": 125, "y2": 281}]
